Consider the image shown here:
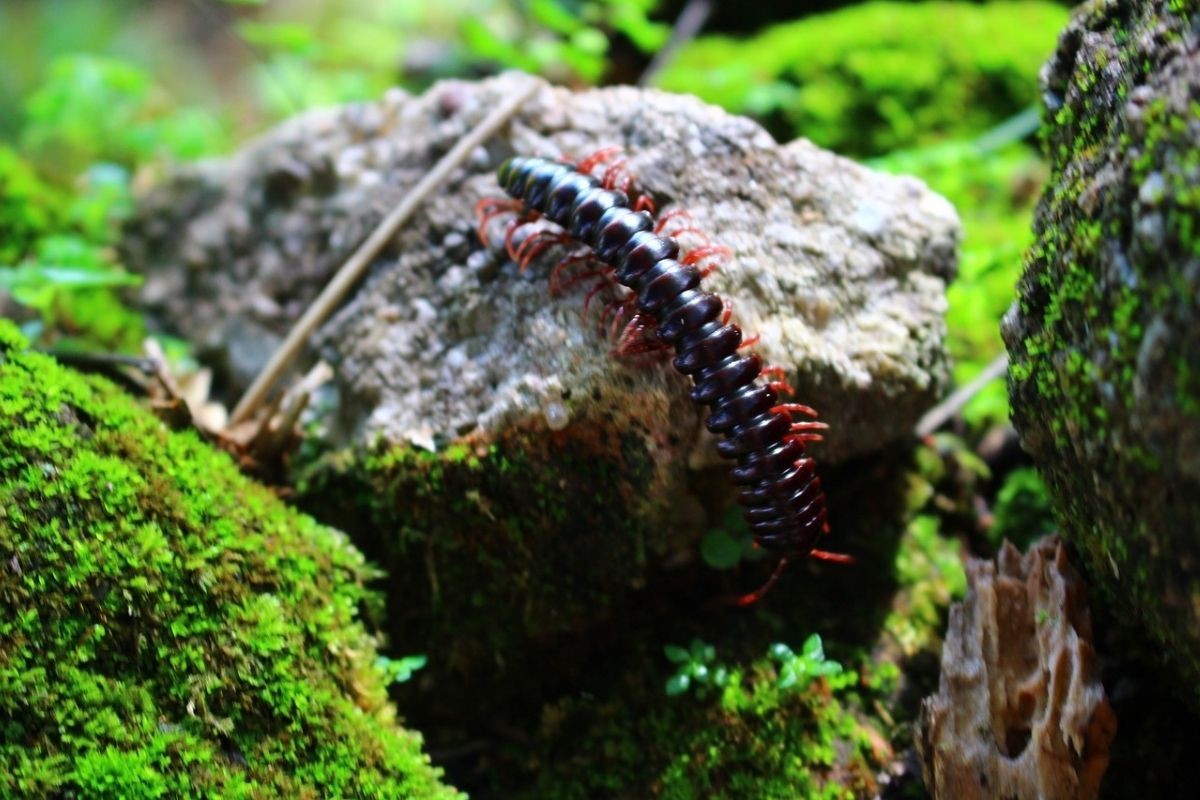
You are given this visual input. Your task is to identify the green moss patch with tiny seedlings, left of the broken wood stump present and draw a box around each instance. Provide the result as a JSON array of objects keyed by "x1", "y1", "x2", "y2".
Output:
[{"x1": 509, "y1": 642, "x2": 882, "y2": 800}]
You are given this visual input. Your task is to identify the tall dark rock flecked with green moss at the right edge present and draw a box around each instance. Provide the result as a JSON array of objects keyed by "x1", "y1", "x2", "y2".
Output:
[{"x1": 1004, "y1": 2, "x2": 1200, "y2": 703}]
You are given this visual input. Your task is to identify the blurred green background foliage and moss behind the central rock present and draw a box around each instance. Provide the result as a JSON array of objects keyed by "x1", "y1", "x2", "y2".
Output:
[{"x1": 0, "y1": 0, "x2": 1068, "y2": 542}]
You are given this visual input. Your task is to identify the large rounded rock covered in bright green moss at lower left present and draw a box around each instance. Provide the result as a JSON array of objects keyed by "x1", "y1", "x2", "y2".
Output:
[{"x1": 0, "y1": 320, "x2": 461, "y2": 798}]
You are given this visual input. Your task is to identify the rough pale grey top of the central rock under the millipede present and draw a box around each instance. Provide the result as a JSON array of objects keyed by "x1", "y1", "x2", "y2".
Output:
[{"x1": 126, "y1": 76, "x2": 958, "y2": 463}]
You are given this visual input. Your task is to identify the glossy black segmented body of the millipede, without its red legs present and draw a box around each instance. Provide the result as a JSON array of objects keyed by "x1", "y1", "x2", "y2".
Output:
[{"x1": 499, "y1": 157, "x2": 827, "y2": 557}]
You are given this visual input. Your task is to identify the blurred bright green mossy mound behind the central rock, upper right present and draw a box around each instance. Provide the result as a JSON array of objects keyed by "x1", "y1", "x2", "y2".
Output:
[{"x1": 659, "y1": 1, "x2": 1067, "y2": 156}]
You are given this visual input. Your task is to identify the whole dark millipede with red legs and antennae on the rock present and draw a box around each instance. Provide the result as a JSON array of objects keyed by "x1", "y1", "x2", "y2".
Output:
[{"x1": 476, "y1": 148, "x2": 852, "y2": 607}]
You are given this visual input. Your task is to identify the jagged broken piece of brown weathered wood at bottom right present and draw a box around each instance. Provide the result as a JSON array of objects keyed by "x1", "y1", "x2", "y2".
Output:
[{"x1": 918, "y1": 537, "x2": 1116, "y2": 800}]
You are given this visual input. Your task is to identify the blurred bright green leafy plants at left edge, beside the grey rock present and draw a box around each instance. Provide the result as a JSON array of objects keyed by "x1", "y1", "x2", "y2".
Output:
[{"x1": 0, "y1": 55, "x2": 227, "y2": 350}]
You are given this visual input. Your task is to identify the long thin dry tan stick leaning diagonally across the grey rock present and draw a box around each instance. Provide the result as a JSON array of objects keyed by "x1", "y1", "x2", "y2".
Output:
[{"x1": 229, "y1": 79, "x2": 541, "y2": 425}]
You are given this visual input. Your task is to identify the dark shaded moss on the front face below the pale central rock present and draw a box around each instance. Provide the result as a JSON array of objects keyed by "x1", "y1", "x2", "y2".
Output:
[{"x1": 298, "y1": 425, "x2": 665, "y2": 681}]
